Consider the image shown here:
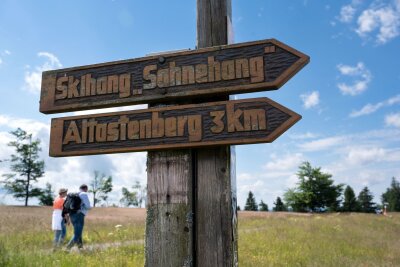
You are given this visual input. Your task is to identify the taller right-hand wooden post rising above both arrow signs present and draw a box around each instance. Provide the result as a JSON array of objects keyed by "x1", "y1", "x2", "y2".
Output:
[{"x1": 193, "y1": 0, "x2": 238, "y2": 266}]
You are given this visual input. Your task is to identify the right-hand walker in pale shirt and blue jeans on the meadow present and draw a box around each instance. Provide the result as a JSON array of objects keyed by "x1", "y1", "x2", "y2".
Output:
[{"x1": 67, "y1": 184, "x2": 91, "y2": 249}]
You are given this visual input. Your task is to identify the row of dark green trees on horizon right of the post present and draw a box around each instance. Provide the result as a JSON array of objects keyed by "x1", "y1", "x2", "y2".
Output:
[{"x1": 238, "y1": 162, "x2": 400, "y2": 213}]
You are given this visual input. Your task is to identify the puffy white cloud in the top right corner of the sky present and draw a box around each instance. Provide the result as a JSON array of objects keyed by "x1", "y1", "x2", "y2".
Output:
[{"x1": 356, "y1": 1, "x2": 400, "y2": 44}]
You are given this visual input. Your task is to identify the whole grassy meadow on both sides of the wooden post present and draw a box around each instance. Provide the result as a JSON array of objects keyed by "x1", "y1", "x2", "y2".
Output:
[{"x1": 0, "y1": 206, "x2": 400, "y2": 267}]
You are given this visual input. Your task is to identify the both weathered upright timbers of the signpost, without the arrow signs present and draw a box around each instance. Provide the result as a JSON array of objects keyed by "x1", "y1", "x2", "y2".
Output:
[{"x1": 145, "y1": 0, "x2": 237, "y2": 267}]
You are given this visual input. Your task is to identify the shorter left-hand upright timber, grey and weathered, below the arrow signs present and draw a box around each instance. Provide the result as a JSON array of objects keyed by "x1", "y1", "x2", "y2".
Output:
[{"x1": 145, "y1": 150, "x2": 194, "y2": 267}]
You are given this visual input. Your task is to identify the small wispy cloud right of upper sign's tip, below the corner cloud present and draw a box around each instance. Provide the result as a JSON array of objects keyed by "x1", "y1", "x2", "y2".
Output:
[{"x1": 337, "y1": 62, "x2": 372, "y2": 96}]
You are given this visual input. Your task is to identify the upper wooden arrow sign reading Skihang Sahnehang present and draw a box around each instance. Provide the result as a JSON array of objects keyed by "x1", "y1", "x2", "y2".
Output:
[{"x1": 40, "y1": 39, "x2": 309, "y2": 113}]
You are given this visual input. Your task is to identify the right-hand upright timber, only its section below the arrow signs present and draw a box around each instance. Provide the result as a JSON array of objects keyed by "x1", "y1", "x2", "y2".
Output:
[{"x1": 196, "y1": 146, "x2": 237, "y2": 266}]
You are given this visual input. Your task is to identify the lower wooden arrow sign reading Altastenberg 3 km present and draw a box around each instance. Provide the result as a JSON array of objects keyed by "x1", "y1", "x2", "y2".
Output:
[{"x1": 50, "y1": 98, "x2": 301, "y2": 157}]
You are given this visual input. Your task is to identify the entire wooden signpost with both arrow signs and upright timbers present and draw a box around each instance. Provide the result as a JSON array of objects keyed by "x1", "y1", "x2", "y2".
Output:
[{"x1": 40, "y1": 0, "x2": 309, "y2": 267}]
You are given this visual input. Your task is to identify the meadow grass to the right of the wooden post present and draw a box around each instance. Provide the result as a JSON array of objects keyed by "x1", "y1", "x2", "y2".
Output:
[{"x1": 239, "y1": 214, "x2": 400, "y2": 266}]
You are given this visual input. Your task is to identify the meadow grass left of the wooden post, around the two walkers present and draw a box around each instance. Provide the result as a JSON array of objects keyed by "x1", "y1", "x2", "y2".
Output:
[{"x1": 0, "y1": 206, "x2": 144, "y2": 267}]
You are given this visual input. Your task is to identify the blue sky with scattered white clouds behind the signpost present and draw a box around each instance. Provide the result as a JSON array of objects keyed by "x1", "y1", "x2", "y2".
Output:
[{"x1": 0, "y1": 0, "x2": 400, "y2": 208}]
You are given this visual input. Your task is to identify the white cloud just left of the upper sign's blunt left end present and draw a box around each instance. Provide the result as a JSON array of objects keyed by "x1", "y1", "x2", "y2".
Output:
[{"x1": 24, "y1": 52, "x2": 62, "y2": 94}]
